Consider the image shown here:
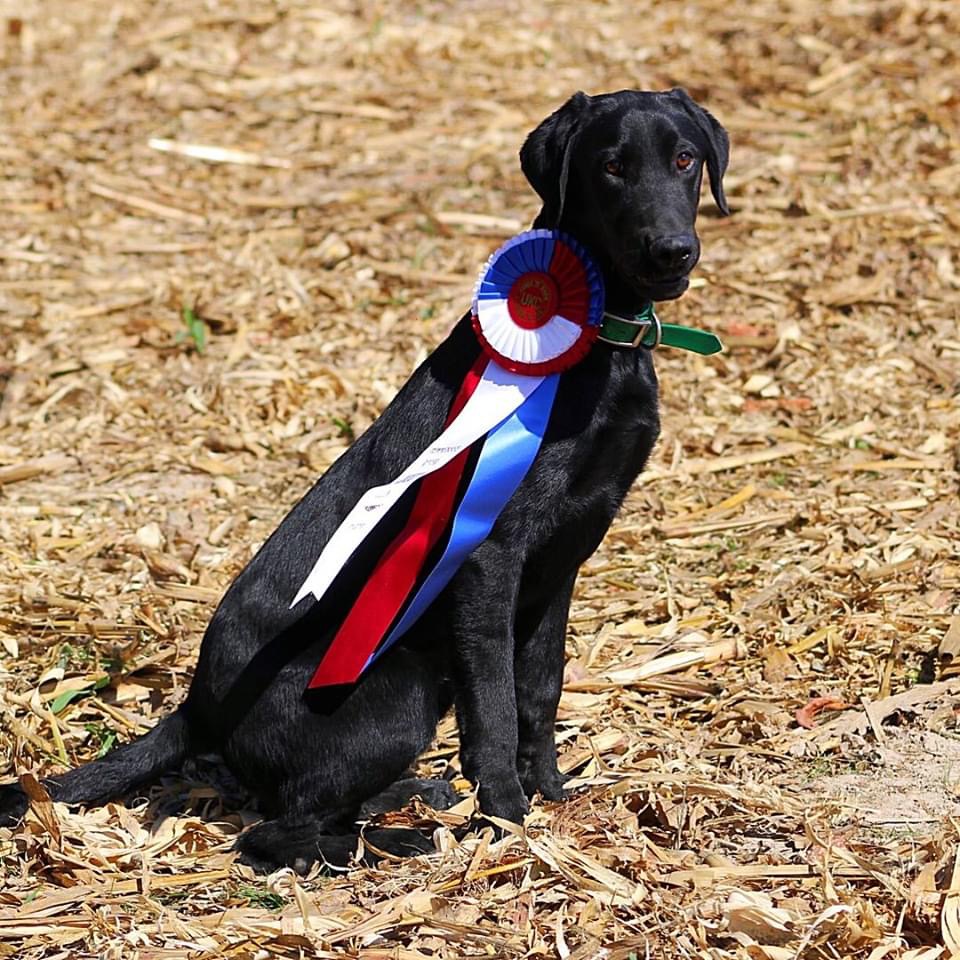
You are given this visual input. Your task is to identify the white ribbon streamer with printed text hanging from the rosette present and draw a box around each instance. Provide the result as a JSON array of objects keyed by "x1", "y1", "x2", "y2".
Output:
[{"x1": 290, "y1": 360, "x2": 543, "y2": 607}]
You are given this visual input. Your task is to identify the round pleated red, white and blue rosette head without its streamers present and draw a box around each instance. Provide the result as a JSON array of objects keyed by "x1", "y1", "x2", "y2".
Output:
[{"x1": 473, "y1": 230, "x2": 604, "y2": 376}]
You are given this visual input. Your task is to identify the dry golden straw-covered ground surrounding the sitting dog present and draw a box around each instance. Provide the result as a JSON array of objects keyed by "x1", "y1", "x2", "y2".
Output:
[{"x1": 0, "y1": 0, "x2": 960, "y2": 960}]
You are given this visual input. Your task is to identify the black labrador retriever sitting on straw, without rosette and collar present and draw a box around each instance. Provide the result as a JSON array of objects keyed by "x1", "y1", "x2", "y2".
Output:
[{"x1": 0, "y1": 89, "x2": 728, "y2": 870}]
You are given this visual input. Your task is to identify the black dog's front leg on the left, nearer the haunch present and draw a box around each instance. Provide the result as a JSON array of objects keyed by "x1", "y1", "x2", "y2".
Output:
[{"x1": 454, "y1": 541, "x2": 529, "y2": 823}]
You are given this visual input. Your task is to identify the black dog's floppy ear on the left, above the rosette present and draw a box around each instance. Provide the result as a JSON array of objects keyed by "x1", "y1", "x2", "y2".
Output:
[{"x1": 520, "y1": 91, "x2": 590, "y2": 226}]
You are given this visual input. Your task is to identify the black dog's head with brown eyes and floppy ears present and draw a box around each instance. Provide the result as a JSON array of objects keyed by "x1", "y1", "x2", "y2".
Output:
[{"x1": 520, "y1": 89, "x2": 729, "y2": 300}]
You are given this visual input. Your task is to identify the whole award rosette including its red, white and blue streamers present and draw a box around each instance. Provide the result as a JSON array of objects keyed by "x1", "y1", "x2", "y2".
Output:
[{"x1": 291, "y1": 230, "x2": 604, "y2": 688}]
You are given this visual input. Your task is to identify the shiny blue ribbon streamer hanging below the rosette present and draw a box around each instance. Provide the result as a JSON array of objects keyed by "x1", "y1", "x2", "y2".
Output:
[{"x1": 364, "y1": 373, "x2": 560, "y2": 670}]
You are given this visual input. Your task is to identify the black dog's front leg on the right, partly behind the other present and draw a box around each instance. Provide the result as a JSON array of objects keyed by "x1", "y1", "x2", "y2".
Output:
[{"x1": 514, "y1": 571, "x2": 577, "y2": 800}]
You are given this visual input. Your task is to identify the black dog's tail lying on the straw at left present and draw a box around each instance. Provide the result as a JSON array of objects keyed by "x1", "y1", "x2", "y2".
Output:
[{"x1": 0, "y1": 707, "x2": 192, "y2": 823}]
